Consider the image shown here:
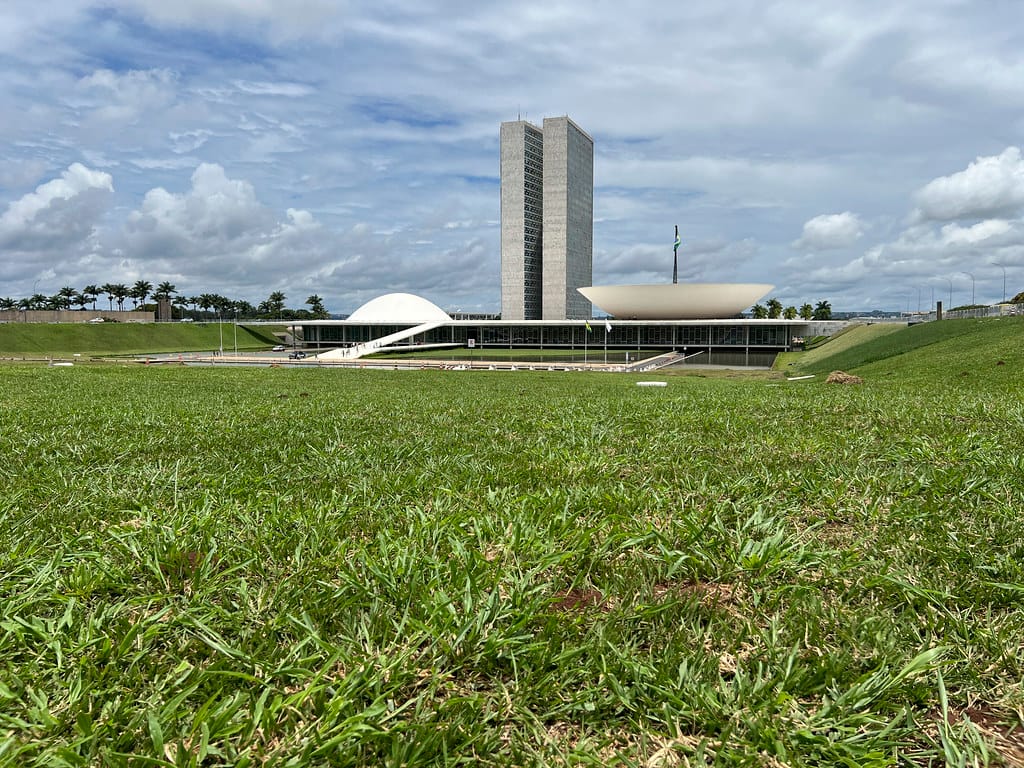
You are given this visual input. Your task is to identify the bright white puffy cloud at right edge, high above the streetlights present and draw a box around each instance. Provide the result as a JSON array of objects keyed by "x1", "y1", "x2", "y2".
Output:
[{"x1": 916, "y1": 146, "x2": 1024, "y2": 221}]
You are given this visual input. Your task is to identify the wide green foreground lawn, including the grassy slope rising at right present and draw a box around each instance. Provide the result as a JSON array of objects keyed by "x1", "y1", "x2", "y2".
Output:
[{"x1": 0, "y1": 321, "x2": 1024, "y2": 766}]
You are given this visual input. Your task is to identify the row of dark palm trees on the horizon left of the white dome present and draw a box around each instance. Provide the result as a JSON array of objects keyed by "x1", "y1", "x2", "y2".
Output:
[{"x1": 0, "y1": 280, "x2": 330, "y2": 321}]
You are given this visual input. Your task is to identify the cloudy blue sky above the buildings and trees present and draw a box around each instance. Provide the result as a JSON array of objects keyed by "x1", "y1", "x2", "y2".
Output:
[{"x1": 0, "y1": 0, "x2": 1024, "y2": 313}]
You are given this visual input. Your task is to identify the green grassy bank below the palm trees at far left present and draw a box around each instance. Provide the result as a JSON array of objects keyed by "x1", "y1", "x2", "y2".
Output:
[{"x1": 0, "y1": 323, "x2": 278, "y2": 357}]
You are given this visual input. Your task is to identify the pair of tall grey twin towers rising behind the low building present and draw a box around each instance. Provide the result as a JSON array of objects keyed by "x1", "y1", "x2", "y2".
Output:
[{"x1": 501, "y1": 118, "x2": 594, "y2": 319}]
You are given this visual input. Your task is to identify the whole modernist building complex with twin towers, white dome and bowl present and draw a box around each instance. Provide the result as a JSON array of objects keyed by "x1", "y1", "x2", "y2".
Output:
[{"x1": 284, "y1": 117, "x2": 822, "y2": 368}]
